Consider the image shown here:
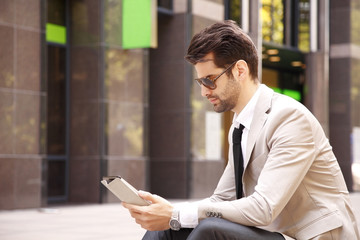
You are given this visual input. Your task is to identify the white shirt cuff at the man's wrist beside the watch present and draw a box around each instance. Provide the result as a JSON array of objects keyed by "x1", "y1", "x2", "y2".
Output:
[{"x1": 174, "y1": 202, "x2": 199, "y2": 228}]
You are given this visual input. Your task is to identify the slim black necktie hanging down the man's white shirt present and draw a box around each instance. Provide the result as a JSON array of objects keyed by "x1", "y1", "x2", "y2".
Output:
[{"x1": 233, "y1": 124, "x2": 244, "y2": 199}]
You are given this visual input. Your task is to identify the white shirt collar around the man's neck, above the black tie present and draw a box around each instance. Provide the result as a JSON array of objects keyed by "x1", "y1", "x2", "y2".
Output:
[{"x1": 233, "y1": 85, "x2": 262, "y2": 130}]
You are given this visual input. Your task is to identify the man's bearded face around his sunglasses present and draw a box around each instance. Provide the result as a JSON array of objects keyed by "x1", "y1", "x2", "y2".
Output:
[{"x1": 195, "y1": 53, "x2": 240, "y2": 113}]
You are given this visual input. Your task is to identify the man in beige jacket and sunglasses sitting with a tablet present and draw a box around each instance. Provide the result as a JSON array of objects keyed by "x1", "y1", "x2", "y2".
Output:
[{"x1": 123, "y1": 21, "x2": 360, "y2": 240}]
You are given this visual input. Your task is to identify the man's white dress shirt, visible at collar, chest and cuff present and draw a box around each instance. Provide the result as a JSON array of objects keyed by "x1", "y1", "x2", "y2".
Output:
[{"x1": 174, "y1": 85, "x2": 263, "y2": 228}]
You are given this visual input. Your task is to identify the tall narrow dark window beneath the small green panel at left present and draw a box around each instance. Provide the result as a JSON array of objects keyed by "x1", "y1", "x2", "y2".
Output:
[{"x1": 46, "y1": 45, "x2": 67, "y2": 202}]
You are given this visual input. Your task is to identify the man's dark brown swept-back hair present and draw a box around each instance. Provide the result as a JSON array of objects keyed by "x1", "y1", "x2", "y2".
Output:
[{"x1": 185, "y1": 20, "x2": 258, "y2": 79}]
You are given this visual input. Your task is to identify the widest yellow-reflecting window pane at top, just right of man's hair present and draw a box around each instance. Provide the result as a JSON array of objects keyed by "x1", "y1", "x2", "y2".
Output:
[{"x1": 261, "y1": 0, "x2": 284, "y2": 45}]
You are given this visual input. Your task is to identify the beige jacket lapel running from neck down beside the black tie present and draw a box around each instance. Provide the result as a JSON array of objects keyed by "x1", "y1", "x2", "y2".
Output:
[{"x1": 244, "y1": 84, "x2": 274, "y2": 170}]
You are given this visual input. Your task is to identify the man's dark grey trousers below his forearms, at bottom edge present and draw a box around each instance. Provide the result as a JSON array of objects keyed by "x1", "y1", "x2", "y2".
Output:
[{"x1": 143, "y1": 218, "x2": 284, "y2": 240}]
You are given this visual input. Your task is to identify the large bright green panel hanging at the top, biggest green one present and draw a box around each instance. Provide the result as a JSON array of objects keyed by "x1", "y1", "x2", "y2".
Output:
[{"x1": 122, "y1": 0, "x2": 152, "y2": 49}]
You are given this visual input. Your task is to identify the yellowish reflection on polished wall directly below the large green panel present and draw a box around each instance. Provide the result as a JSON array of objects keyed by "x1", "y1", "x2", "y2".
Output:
[{"x1": 105, "y1": 49, "x2": 145, "y2": 157}]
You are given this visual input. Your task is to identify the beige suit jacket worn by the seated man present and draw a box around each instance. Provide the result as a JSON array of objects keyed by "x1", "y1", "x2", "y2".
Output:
[{"x1": 198, "y1": 85, "x2": 360, "y2": 240}]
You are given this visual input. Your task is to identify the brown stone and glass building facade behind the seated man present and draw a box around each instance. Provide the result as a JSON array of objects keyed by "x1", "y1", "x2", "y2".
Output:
[{"x1": 0, "y1": 0, "x2": 360, "y2": 209}]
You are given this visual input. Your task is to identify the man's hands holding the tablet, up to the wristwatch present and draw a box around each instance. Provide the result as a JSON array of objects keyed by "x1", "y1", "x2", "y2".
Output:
[{"x1": 122, "y1": 191, "x2": 174, "y2": 231}]
